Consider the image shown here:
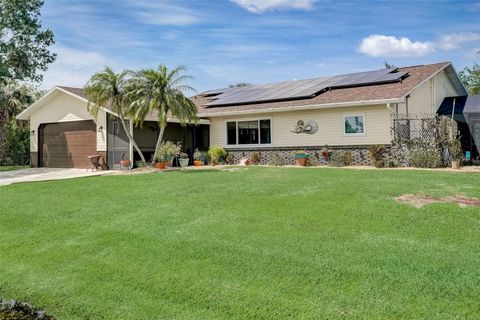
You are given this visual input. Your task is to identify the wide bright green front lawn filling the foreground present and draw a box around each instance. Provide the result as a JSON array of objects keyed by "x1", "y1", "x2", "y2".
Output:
[{"x1": 0, "y1": 168, "x2": 480, "y2": 320}]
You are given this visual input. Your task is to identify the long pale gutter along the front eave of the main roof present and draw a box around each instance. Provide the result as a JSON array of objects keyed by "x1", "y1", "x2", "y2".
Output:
[{"x1": 198, "y1": 98, "x2": 404, "y2": 118}]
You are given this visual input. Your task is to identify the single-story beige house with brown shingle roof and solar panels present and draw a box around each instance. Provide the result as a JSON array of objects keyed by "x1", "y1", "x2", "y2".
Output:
[{"x1": 17, "y1": 62, "x2": 467, "y2": 168}]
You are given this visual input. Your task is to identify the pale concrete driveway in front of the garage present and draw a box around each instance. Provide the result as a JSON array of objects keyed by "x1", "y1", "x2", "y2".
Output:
[{"x1": 0, "y1": 168, "x2": 113, "y2": 186}]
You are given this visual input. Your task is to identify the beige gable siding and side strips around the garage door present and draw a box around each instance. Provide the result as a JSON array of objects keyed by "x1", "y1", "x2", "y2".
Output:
[{"x1": 30, "y1": 92, "x2": 107, "y2": 152}]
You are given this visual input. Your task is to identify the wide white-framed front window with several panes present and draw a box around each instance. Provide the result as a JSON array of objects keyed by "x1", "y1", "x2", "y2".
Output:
[{"x1": 227, "y1": 119, "x2": 272, "y2": 145}]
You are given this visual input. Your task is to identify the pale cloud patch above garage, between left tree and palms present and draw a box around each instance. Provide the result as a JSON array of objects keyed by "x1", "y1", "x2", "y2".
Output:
[{"x1": 41, "y1": 46, "x2": 117, "y2": 89}]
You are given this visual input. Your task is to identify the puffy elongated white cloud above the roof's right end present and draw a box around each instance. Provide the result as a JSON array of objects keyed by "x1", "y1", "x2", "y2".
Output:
[{"x1": 359, "y1": 34, "x2": 435, "y2": 57}]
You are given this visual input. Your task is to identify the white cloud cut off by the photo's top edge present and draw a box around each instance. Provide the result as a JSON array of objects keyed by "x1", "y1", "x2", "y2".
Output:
[{"x1": 231, "y1": 0, "x2": 317, "y2": 13}]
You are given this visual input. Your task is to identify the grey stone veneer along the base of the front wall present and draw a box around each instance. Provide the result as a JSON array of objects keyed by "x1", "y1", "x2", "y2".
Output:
[{"x1": 225, "y1": 146, "x2": 382, "y2": 166}]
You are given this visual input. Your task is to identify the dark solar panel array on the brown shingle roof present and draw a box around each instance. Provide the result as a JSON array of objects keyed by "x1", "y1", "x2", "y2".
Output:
[{"x1": 202, "y1": 69, "x2": 407, "y2": 107}]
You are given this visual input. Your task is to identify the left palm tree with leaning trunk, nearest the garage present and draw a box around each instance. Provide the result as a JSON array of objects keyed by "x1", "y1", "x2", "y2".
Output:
[{"x1": 85, "y1": 67, "x2": 146, "y2": 163}]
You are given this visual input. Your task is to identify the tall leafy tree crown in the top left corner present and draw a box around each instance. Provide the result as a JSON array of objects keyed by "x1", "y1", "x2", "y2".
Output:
[{"x1": 0, "y1": 0, "x2": 56, "y2": 85}]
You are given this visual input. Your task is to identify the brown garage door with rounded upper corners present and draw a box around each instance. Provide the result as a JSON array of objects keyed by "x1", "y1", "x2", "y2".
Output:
[{"x1": 39, "y1": 121, "x2": 97, "y2": 168}]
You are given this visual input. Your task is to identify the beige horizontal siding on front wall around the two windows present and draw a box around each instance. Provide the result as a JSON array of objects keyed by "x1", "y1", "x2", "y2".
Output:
[{"x1": 210, "y1": 105, "x2": 390, "y2": 147}]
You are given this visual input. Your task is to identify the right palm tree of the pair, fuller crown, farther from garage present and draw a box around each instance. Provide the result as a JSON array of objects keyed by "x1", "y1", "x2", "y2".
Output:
[{"x1": 128, "y1": 65, "x2": 198, "y2": 159}]
